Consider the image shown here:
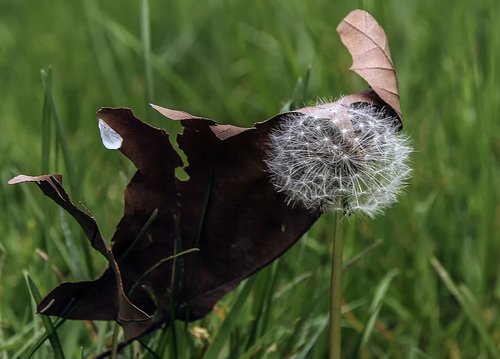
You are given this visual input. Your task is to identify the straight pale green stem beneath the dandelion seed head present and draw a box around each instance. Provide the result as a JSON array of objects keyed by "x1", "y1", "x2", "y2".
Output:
[{"x1": 330, "y1": 211, "x2": 342, "y2": 359}]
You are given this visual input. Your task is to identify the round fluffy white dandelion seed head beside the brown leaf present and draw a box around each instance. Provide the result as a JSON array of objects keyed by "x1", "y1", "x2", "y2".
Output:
[{"x1": 266, "y1": 99, "x2": 412, "y2": 217}]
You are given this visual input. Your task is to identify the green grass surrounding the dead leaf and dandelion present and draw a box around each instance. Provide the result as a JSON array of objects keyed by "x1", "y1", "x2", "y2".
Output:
[{"x1": 0, "y1": 0, "x2": 500, "y2": 359}]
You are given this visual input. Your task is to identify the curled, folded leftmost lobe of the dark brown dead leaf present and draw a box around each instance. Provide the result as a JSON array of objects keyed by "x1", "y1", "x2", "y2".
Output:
[{"x1": 9, "y1": 175, "x2": 151, "y2": 338}]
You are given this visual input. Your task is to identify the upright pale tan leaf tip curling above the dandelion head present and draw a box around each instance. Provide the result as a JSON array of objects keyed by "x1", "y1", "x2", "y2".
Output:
[{"x1": 337, "y1": 10, "x2": 403, "y2": 127}]
